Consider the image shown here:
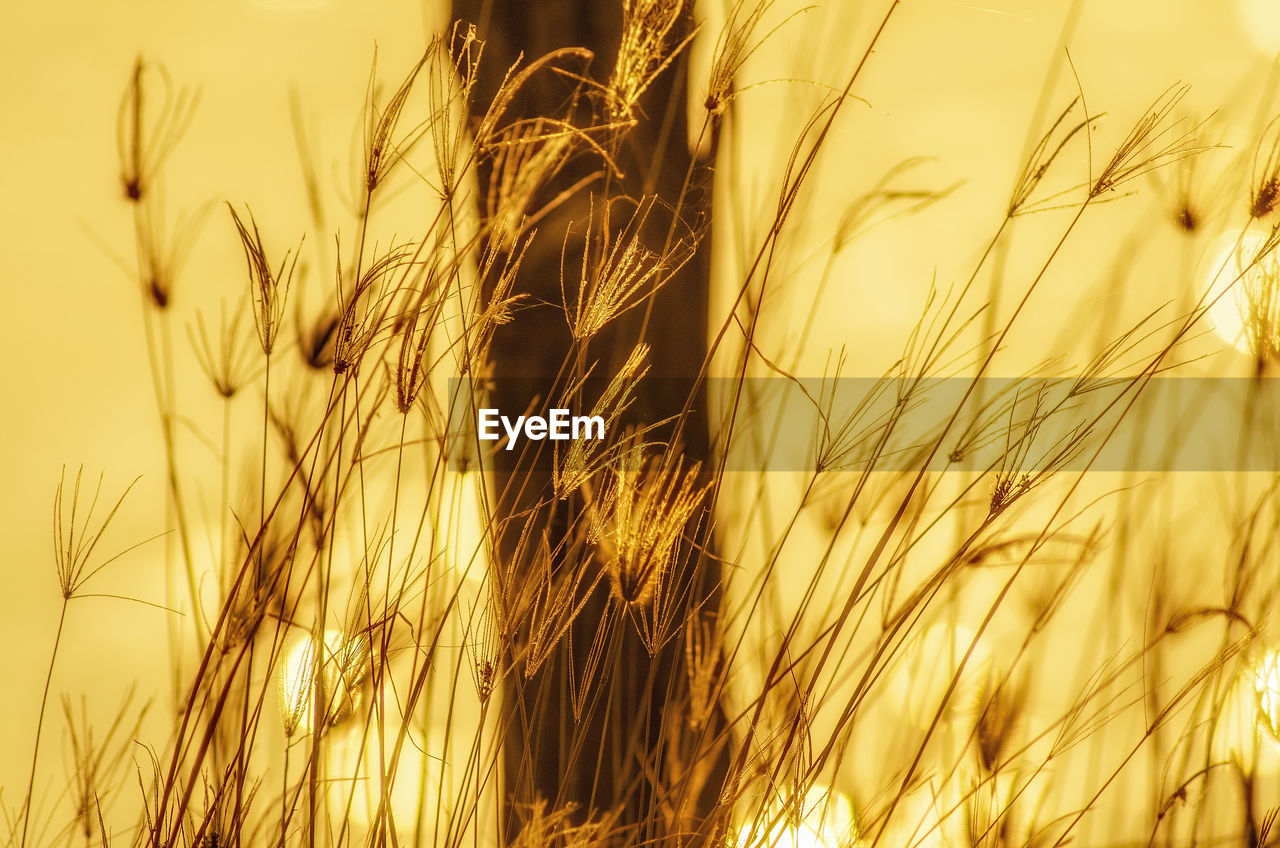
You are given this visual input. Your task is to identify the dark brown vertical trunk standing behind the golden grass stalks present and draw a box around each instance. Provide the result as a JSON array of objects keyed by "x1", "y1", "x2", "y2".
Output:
[{"x1": 452, "y1": 0, "x2": 719, "y2": 842}]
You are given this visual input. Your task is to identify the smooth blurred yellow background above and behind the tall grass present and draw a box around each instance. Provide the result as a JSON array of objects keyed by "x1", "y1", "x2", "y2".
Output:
[{"x1": 0, "y1": 0, "x2": 1280, "y2": 844}]
